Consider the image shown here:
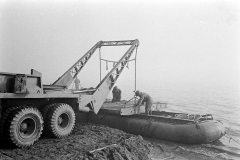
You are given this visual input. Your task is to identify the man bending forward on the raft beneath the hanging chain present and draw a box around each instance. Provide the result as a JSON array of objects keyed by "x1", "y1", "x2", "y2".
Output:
[{"x1": 135, "y1": 91, "x2": 153, "y2": 115}]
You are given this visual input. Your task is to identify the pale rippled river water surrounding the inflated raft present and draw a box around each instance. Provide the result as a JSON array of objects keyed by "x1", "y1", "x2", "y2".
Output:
[{"x1": 142, "y1": 85, "x2": 240, "y2": 160}]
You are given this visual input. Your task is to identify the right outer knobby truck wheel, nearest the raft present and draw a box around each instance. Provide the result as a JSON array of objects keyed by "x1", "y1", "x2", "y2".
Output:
[{"x1": 45, "y1": 103, "x2": 75, "y2": 138}]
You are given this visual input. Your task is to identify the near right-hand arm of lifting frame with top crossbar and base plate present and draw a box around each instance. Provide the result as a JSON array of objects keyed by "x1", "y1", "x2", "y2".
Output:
[{"x1": 75, "y1": 39, "x2": 139, "y2": 114}]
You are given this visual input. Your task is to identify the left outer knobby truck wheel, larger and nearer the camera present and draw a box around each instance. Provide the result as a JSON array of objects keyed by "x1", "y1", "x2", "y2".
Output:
[{"x1": 6, "y1": 107, "x2": 43, "y2": 147}]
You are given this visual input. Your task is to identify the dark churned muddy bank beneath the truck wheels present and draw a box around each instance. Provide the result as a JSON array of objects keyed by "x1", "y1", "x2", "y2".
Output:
[{"x1": 0, "y1": 123, "x2": 154, "y2": 160}]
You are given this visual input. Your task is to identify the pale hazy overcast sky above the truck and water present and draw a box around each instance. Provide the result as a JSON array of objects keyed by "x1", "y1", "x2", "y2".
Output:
[{"x1": 0, "y1": 0, "x2": 240, "y2": 95}]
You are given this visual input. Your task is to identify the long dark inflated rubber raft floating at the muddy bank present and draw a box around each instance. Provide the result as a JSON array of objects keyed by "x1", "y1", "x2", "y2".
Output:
[{"x1": 89, "y1": 111, "x2": 225, "y2": 144}]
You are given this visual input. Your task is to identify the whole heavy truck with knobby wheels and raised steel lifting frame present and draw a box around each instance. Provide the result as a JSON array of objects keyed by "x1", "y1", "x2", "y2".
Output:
[{"x1": 0, "y1": 39, "x2": 139, "y2": 147}]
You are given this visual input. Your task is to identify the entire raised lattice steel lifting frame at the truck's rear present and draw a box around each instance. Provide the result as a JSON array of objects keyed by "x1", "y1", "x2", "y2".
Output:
[{"x1": 53, "y1": 39, "x2": 139, "y2": 114}]
